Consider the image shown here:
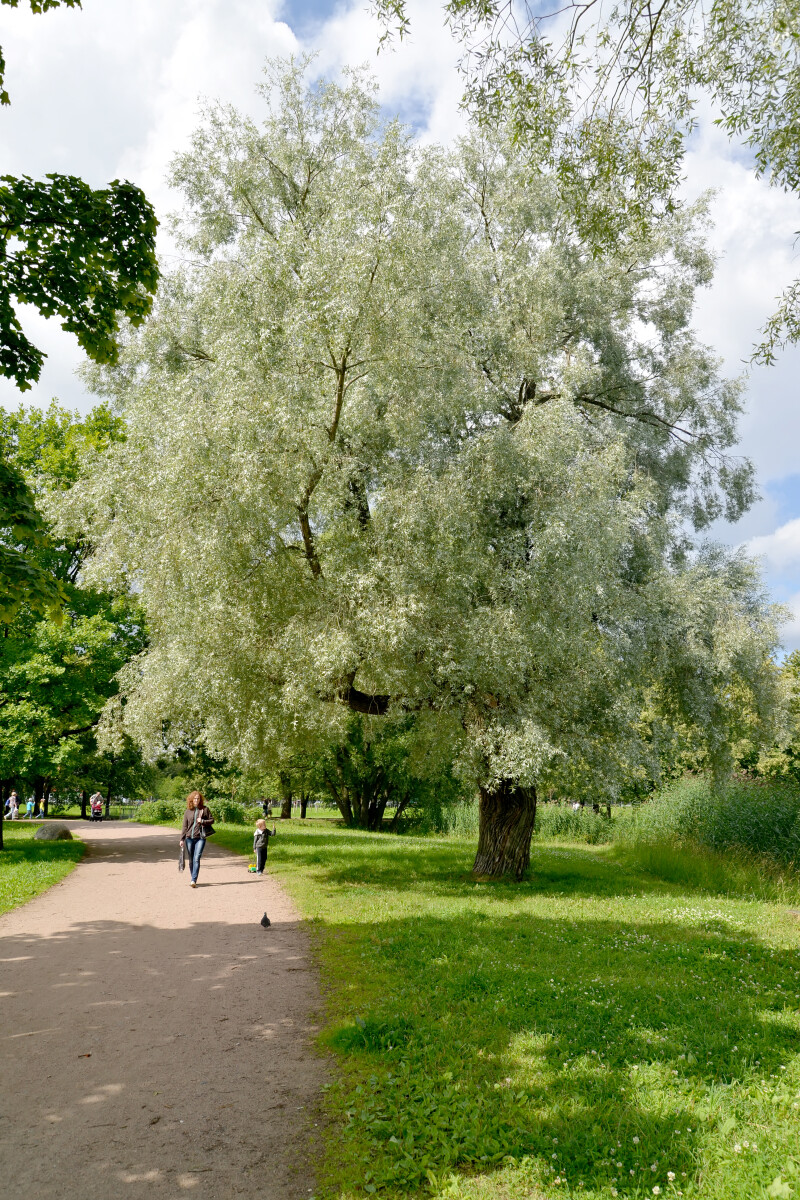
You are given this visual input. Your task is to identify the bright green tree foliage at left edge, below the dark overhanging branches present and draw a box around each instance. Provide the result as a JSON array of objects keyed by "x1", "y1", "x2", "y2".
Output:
[{"x1": 0, "y1": 402, "x2": 149, "y2": 794}]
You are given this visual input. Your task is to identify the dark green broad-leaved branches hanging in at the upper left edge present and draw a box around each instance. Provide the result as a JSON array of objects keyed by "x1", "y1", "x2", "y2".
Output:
[{"x1": 0, "y1": 0, "x2": 158, "y2": 623}]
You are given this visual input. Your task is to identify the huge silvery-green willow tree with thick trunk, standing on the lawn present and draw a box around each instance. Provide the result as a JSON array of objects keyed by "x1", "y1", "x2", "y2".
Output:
[{"x1": 64, "y1": 60, "x2": 774, "y2": 876}]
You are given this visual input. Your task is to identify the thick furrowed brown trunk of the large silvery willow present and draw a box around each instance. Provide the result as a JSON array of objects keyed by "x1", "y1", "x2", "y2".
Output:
[{"x1": 473, "y1": 779, "x2": 536, "y2": 880}]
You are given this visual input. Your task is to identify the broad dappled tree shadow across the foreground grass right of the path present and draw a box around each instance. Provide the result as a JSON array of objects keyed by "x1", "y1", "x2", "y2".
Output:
[{"x1": 319, "y1": 910, "x2": 800, "y2": 1196}]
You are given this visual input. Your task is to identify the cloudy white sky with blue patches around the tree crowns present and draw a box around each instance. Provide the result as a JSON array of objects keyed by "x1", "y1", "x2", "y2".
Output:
[{"x1": 0, "y1": 0, "x2": 800, "y2": 648}]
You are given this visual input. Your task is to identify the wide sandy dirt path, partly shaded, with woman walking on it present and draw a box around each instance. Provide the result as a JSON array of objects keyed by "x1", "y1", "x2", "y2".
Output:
[{"x1": 0, "y1": 822, "x2": 324, "y2": 1200}]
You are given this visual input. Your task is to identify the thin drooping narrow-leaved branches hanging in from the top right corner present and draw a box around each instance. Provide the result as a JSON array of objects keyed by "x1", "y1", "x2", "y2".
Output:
[{"x1": 373, "y1": 0, "x2": 800, "y2": 362}]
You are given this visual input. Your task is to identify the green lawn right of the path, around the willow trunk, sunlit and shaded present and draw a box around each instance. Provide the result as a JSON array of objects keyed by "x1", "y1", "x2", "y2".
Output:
[{"x1": 208, "y1": 820, "x2": 800, "y2": 1200}]
